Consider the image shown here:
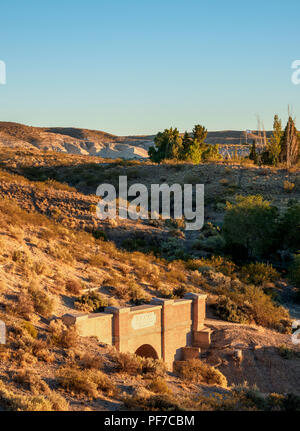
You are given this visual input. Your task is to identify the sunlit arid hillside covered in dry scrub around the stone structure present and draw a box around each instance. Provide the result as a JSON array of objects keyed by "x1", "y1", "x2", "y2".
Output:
[{"x1": 0, "y1": 149, "x2": 300, "y2": 411}]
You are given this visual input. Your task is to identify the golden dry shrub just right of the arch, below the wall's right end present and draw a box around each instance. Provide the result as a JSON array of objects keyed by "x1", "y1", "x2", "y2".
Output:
[{"x1": 174, "y1": 359, "x2": 227, "y2": 388}]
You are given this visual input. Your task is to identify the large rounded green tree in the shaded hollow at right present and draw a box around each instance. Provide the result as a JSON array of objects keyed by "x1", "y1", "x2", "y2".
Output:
[{"x1": 222, "y1": 195, "x2": 278, "y2": 258}]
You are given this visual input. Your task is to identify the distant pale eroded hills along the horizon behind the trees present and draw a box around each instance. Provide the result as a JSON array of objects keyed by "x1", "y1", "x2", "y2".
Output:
[{"x1": 0, "y1": 122, "x2": 270, "y2": 159}]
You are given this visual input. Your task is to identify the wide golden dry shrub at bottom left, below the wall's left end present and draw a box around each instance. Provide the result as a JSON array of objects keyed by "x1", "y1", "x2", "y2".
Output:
[{"x1": 57, "y1": 367, "x2": 117, "y2": 398}]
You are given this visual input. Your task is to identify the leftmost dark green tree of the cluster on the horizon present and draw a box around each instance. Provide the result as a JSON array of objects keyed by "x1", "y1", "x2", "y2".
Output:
[{"x1": 148, "y1": 127, "x2": 182, "y2": 163}]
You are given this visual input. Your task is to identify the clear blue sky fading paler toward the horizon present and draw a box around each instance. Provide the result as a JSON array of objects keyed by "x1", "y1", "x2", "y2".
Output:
[{"x1": 0, "y1": 0, "x2": 300, "y2": 135}]
